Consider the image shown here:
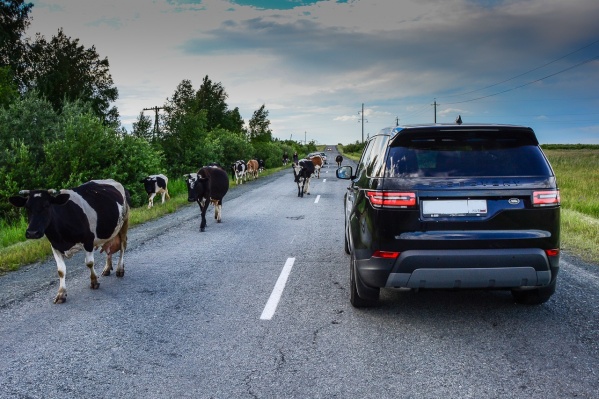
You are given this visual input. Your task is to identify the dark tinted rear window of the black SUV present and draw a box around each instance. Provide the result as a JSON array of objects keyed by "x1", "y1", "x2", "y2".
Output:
[{"x1": 385, "y1": 131, "x2": 552, "y2": 178}]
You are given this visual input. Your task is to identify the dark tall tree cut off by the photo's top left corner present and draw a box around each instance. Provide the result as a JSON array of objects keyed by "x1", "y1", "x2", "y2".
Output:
[{"x1": 0, "y1": 0, "x2": 33, "y2": 86}]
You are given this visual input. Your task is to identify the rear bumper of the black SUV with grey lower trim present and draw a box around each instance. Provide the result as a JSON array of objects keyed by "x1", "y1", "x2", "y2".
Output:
[{"x1": 356, "y1": 248, "x2": 559, "y2": 289}]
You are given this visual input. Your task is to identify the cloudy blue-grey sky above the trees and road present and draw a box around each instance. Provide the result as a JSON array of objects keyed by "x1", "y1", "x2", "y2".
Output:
[{"x1": 26, "y1": 0, "x2": 599, "y2": 145}]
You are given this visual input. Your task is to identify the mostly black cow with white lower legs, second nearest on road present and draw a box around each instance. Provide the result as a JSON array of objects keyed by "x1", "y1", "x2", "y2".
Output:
[{"x1": 185, "y1": 166, "x2": 229, "y2": 231}]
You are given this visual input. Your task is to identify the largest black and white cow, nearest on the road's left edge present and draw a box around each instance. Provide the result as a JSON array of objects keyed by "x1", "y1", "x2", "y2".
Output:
[{"x1": 9, "y1": 180, "x2": 129, "y2": 303}]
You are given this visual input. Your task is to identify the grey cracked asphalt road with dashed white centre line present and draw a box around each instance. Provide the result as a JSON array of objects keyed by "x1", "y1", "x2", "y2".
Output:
[{"x1": 0, "y1": 152, "x2": 599, "y2": 399}]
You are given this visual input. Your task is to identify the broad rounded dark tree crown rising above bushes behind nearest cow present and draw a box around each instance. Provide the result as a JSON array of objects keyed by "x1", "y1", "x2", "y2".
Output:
[{"x1": 24, "y1": 29, "x2": 119, "y2": 126}]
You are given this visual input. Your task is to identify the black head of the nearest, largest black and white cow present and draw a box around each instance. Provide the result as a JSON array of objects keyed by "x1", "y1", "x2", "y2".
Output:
[{"x1": 8, "y1": 190, "x2": 70, "y2": 238}]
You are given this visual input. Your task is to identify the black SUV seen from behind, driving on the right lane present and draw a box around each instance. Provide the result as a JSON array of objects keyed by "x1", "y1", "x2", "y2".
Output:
[{"x1": 336, "y1": 124, "x2": 560, "y2": 307}]
